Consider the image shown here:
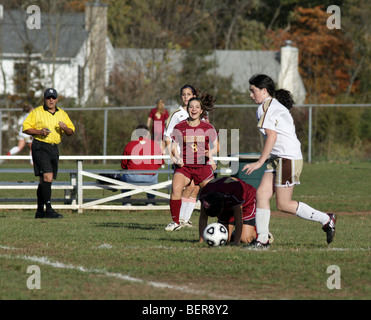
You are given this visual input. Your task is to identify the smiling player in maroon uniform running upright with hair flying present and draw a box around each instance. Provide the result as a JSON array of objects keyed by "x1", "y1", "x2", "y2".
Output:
[{"x1": 165, "y1": 93, "x2": 218, "y2": 231}]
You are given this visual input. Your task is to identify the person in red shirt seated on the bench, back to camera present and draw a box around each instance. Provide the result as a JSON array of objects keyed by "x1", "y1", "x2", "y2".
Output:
[{"x1": 121, "y1": 125, "x2": 163, "y2": 205}]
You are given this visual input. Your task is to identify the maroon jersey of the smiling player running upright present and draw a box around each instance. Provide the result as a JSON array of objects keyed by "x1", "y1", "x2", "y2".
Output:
[{"x1": 172, "y1": 120, "x2": 218, "y2": 166}]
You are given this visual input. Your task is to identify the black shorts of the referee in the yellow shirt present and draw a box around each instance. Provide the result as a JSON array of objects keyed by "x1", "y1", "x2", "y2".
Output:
[{"x1": 32, "y1": 139, "x2": 59, "y2": 179}]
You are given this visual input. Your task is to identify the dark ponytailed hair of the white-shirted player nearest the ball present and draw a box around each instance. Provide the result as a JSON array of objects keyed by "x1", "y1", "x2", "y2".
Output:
[{"x1": 249, "y1": 74, "x2": 295, "y2": 110}]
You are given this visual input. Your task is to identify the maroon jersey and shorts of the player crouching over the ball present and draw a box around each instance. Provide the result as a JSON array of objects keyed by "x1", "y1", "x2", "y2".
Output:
[{"x1": 200, "y1": 177, "x2": 256, "y2": 222}]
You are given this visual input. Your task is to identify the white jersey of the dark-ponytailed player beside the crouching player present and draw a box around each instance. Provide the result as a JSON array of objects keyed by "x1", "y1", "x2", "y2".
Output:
[{"x1": 256, "y1": 98, "x2": 303, "y2": 160}]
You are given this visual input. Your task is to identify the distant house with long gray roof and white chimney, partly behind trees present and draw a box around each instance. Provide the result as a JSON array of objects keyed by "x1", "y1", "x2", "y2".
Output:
[{"x1": 115, "y1": 42, "x2": 306, "y2": 104}]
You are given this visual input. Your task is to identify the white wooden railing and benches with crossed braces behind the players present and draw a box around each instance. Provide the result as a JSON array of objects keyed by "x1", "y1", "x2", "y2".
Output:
[{"x1": 0, "y1": 156, "x2": 239, "y2": 213}]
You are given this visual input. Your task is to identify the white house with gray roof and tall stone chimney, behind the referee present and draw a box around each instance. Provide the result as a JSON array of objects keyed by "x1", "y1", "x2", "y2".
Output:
[{"x1": 0, "y1": 3, "x2": 114, "y2": 103}]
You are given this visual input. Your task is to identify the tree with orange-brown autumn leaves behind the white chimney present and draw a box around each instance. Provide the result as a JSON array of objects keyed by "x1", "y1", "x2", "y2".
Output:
[{"x1": 268, "y1": 6, "x2": 356, "y2": 103}]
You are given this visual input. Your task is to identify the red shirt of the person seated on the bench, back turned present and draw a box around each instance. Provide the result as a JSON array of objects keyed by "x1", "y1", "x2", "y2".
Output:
[{"x1": 121, "y1": 138, "x2": 164, "y2": 170}]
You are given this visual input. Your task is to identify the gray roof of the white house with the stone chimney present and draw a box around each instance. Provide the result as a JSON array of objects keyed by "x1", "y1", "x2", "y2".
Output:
[{"x1": 0, "y1": 10, "x2": 88, "y2": 58}]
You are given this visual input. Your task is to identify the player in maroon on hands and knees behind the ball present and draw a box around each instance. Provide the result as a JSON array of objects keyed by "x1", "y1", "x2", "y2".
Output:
[{"x1": 199, "y1": 177, "x2": 256, "y2": 245}]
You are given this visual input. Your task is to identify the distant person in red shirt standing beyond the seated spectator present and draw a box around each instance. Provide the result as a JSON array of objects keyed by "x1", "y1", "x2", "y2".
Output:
[{"x1": 147, "y1": 99, "x2": 169, "y2": 145}]
